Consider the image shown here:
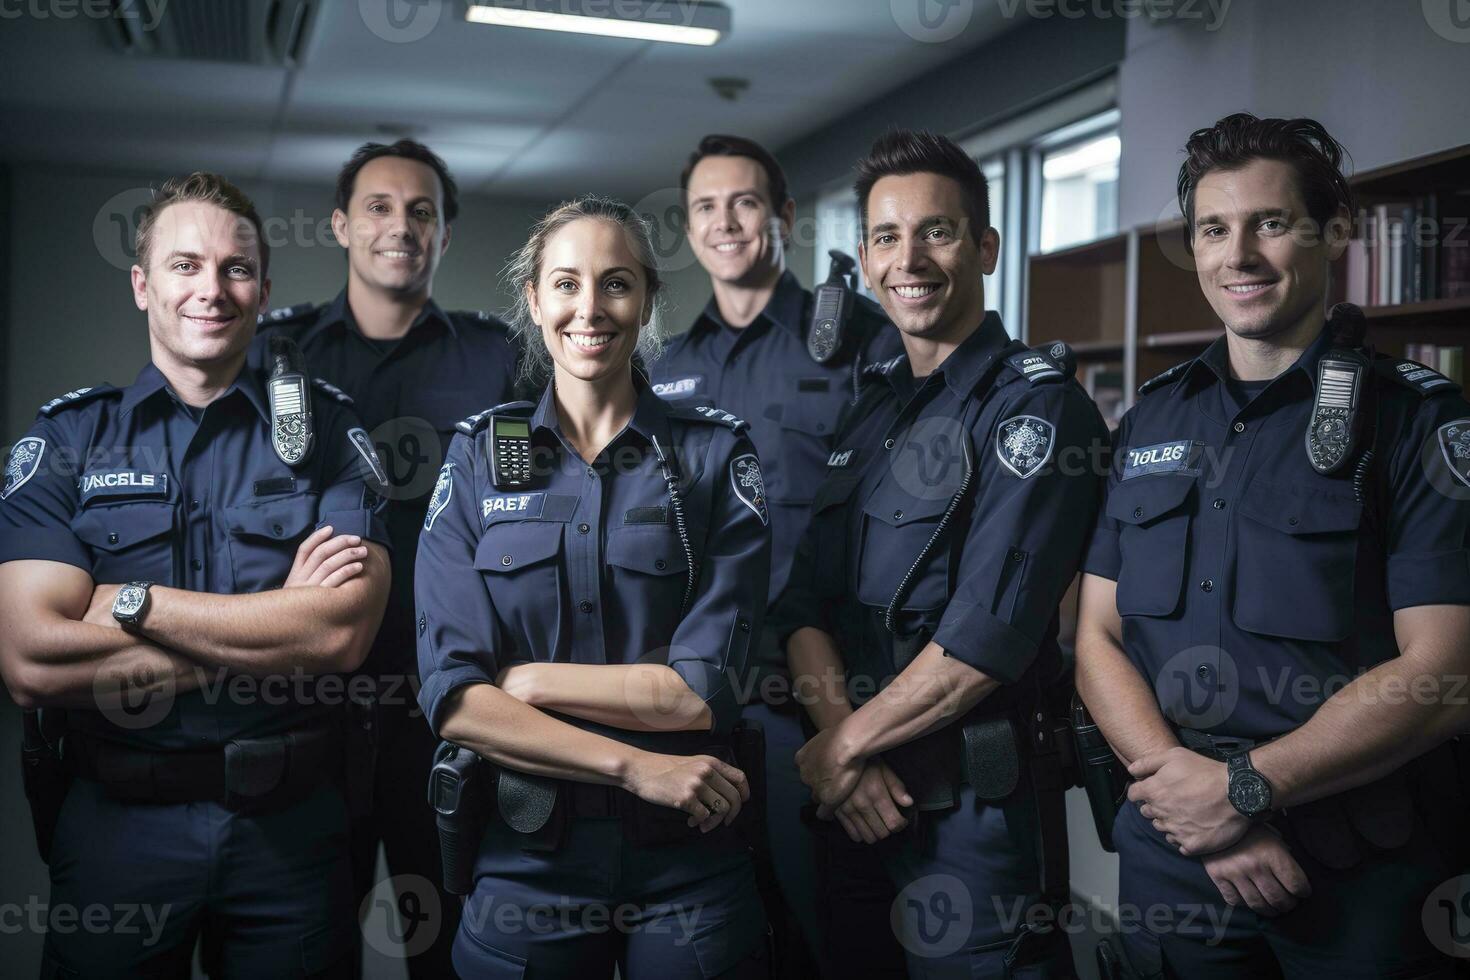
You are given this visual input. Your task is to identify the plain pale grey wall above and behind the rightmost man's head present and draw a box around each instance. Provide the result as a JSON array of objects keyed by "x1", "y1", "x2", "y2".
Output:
[{"x1": 1119, "y1": 0, "x2": 1470, "y2": 228}]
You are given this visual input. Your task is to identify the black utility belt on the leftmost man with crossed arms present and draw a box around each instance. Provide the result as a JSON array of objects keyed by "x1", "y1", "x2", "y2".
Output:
[{"x1": 66, "y1": 718, "x2": 347, "y2": 814}]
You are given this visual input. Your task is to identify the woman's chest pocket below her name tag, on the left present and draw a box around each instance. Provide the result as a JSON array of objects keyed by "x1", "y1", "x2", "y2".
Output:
[{"x1": 475, "y1": 520, "x2": 570, "y2": 661}]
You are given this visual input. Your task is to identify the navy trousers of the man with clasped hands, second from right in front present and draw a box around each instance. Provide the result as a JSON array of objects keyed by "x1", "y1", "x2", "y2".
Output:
[{"x1": 881, "y1": 786, "x2": 1075, "y2": 980}]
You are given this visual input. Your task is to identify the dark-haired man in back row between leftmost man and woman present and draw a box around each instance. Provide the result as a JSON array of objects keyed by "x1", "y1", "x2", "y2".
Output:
[{"x1": 257, "y1": 140, "x2": 516, "y2": 977}]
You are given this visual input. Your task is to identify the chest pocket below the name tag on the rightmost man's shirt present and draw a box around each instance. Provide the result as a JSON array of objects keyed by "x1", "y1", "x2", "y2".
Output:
[{"x1": 1107, "y1": 476, "x2": 1194, "y2": 616}]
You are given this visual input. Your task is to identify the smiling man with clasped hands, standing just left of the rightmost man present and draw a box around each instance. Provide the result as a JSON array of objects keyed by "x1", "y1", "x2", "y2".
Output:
[{"x1": 772, "y1": 131, "x2": 1105, "y2": 977}]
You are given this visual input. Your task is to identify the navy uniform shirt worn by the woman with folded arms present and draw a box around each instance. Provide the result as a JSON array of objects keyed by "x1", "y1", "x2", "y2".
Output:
[{"x1": 416, "y1": 382, "x2": 770, "y2": 739}]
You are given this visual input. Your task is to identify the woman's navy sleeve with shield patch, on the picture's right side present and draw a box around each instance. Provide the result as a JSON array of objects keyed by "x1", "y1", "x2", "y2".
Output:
[{"x1": 669, "y1": 433, "x2": 770, "y2": 735}]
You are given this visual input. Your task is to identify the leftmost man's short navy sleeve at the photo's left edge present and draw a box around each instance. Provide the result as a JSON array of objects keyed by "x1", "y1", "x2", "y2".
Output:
[{"x1": 0, "y1": 419, "x2": 93, "y2": 574}]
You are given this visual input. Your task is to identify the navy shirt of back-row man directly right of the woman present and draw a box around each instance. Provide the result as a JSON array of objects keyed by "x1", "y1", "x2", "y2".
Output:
[{"x1": 651, "y1": 272, "x2": 904, "y2": 620}]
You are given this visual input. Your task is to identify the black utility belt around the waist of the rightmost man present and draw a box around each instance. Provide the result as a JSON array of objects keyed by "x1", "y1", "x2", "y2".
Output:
[{"x1": 1176, "y1": 727, "x2": 1466, "y2": 870}]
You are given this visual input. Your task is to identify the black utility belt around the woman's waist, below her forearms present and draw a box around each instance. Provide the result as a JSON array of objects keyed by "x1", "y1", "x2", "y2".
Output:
[{"x1": 429, "y1": 724, "x2": 766, "y2": 895}]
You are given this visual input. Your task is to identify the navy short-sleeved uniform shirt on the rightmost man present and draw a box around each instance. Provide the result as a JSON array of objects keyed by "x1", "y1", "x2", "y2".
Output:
[{"x1": 1085, "y1": 331, "x2": 1470, "y2": 738}]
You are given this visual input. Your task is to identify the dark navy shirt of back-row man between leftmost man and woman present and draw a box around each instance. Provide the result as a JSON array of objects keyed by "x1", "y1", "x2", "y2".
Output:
[{"x1": 253, "y1": 289, "x2": 516, "y2": 673}]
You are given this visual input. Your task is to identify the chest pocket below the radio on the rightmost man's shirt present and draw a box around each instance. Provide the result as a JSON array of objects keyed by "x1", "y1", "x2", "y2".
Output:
[{"x1": 1235, "y1": 480, "x2": 1363, "y2": 642}]
